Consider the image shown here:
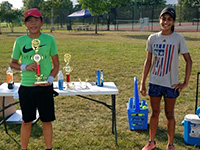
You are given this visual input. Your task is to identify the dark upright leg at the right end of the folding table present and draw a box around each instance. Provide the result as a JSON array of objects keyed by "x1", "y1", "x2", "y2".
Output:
[{"x1": 111, "y1": 95, "x2": 118, "y2": 146}]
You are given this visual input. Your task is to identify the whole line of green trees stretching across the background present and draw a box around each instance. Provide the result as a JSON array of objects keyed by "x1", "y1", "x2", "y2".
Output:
[{"x1": 0, "y1": 0, "x2": 200, "y2": 33}]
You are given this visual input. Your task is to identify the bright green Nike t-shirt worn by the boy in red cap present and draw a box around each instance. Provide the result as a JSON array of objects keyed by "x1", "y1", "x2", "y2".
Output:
[{"x1": 12, "y1": 33, "x2": 58, "y2": 86}]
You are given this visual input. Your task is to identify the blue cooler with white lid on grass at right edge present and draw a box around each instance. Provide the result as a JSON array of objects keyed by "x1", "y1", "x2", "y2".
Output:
[{"x1": 184, "y1": 114, "x2": 200, "y2": 146}]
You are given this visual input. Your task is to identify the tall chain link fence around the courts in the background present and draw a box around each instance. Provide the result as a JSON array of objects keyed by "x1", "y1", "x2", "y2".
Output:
[{"x1": 44, "y1": 5, "x2": 200, "y2": 31}]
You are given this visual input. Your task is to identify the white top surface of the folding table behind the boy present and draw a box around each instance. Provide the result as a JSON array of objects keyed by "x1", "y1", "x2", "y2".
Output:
[{"x1": 0, "y1": 82, "x2": 119, "y2": 97}]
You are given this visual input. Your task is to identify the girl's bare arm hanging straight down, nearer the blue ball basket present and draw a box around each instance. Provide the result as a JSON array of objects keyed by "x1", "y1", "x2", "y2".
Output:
[{"x1": 140, "y1": 52, "x2": 152, "y2": 96}]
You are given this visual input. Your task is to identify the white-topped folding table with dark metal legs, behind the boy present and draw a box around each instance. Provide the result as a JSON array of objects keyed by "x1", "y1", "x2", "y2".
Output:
[{"x1": 0, "y1": 82, "x2": 119, "y2": 145}]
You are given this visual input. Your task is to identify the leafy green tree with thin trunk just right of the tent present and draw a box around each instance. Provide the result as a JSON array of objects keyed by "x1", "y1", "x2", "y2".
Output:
[{"x1": 79, "y1": 0, "x2": 130, "y2": 34}]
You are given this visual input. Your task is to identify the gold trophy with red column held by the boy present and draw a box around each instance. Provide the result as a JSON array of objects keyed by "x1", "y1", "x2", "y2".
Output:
[{"x1": 32, "y1": 39, "x2": 47, "y2": 84}]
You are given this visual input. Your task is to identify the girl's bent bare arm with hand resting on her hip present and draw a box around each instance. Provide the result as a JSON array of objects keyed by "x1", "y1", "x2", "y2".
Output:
[{"x1": 172, "y1": 53, "x2": 192, "y2": 92}]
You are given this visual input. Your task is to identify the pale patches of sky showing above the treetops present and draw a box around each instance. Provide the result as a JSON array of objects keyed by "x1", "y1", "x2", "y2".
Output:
[{"x1": 0, "y1": 0, "x2": 178, "y2": 9}]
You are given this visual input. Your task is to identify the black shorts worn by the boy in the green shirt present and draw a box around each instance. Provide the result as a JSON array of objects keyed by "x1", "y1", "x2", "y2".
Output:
[{"x1": 18, "y1": 85, "x2": 55, "y2": 122}]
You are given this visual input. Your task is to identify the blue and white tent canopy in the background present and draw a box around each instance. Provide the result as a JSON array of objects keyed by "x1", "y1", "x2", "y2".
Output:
[{"x1": 67, "y1": 9, "x2": 92, "y2": 18}]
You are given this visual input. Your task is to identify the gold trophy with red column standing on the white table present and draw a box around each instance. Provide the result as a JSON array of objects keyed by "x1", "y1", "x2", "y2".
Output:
[{"x1": 63, "y1": 54, "x2": 73, "y2": 88}]
